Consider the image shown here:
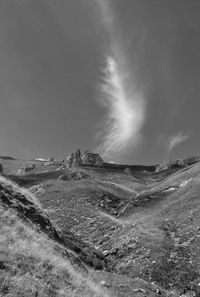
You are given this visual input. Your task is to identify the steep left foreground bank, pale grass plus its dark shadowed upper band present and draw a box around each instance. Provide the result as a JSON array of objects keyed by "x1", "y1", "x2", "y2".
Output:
[{"x1": 0, "y1": 177, "x2": 109, "y2": 297}]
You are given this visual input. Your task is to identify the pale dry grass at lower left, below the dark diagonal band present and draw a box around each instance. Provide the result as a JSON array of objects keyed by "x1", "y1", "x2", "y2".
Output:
[{"x1": 0, "y1": 207, "x2": 108, "y2": 297}]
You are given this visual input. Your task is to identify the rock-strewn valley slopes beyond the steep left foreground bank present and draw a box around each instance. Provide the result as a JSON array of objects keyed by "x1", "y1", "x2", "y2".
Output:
[{"x1": 1, "y1": 154, "x2": 200, "y2": 297}]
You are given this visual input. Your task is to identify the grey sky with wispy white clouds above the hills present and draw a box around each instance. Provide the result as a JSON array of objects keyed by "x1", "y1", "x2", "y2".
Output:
[{"x1": 0, "y1": 0, "x2": 200, "y2": 164}]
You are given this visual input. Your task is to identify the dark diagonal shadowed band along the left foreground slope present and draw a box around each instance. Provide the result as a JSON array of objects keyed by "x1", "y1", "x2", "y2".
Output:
[{"x1": 0, "y1": 177, "x2": 108, "y2": 269}]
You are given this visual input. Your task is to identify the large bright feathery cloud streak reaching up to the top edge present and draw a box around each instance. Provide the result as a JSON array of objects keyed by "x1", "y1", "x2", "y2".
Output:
[{"x1": 91, "y1": 0, "x2": 145, "y2": 159}]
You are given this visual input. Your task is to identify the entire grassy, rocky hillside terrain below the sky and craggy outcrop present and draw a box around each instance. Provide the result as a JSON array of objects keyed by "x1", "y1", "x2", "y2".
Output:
[{"x1": 0, "y1": 153, "x2": 200, "y2": 297}]
